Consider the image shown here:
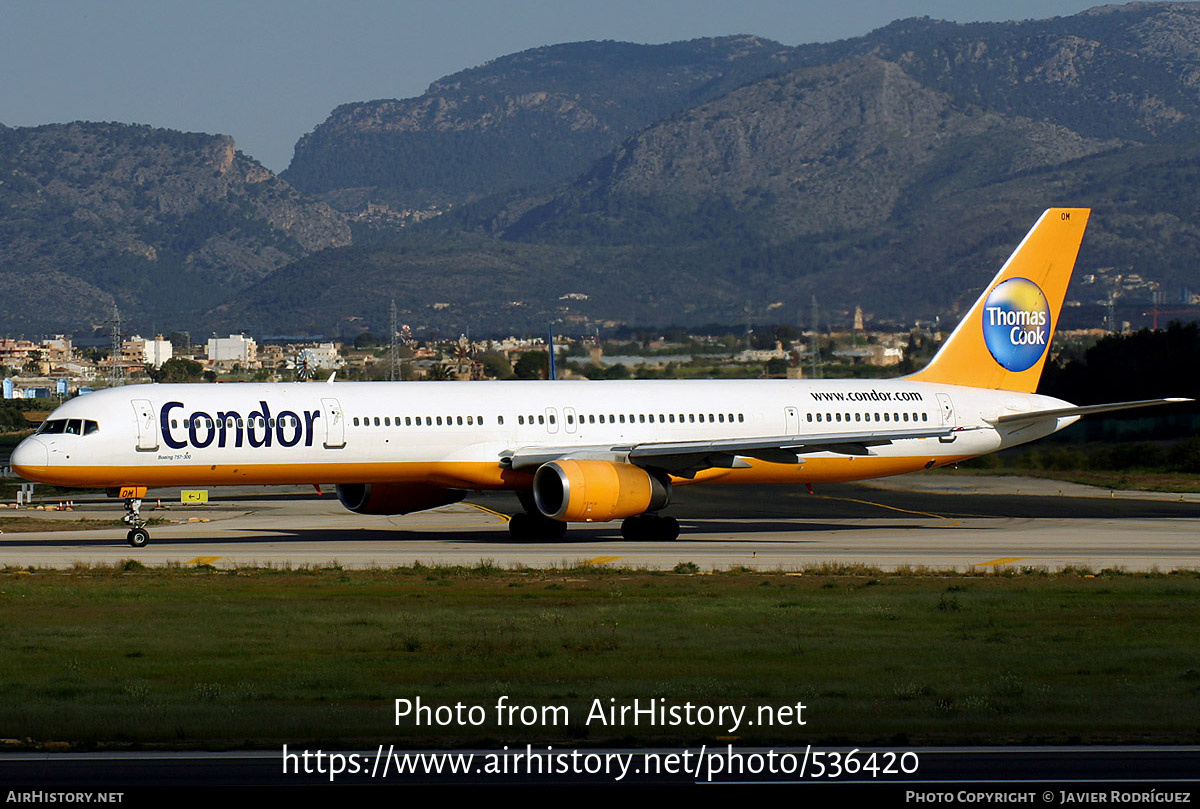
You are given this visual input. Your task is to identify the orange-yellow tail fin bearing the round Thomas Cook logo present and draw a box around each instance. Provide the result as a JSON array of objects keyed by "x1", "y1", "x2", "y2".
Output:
[{"x1": 908, "y1": 208, "x2": 1091, "y2": 392}]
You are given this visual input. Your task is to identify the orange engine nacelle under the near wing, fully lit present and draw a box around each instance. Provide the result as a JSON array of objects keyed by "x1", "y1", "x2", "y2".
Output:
[{"x1": 533, "y1": 459, "x2": 671, "y2": 522}]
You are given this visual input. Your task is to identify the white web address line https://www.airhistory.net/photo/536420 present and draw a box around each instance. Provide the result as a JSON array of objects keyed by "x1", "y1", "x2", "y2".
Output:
[{"x1": 283, "y1": 744, "x2": 919, "y2": 781}]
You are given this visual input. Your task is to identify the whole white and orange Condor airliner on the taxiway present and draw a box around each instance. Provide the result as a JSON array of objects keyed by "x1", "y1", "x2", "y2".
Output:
[{"x1": 12, "y1": 208, "x2": 1188, "y2": 547}]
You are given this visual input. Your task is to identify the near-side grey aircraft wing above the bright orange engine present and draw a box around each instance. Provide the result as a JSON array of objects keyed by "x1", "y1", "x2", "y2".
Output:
[{"x1": 500, "y1": 427, "x2": 958, "y2": 478}]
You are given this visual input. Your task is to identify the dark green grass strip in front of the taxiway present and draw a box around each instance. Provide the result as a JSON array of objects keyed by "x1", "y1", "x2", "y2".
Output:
[{"x1": 0, "y1": 561, "x2": 1200, "y2": 749}]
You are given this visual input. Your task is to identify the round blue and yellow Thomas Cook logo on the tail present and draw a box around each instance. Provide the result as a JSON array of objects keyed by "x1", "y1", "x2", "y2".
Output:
[{"x1": 983, "y1": 273, "x2": 1050, "y2": 371}]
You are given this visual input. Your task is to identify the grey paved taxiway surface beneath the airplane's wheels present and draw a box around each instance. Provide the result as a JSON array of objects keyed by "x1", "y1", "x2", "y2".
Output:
[{"x1": 0, "y1": 475, "x2": 1200, "y2": 571}]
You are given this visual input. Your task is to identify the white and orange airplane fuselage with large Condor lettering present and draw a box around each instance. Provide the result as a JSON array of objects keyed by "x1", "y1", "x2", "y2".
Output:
[{"x1": 13, "y1": 379, "x2": 1076, "y2": 490}]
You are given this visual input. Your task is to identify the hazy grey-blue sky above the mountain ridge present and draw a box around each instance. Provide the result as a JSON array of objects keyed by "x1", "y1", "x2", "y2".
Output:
[{"x1": 0, "y1": 0, "x2": 1123, "y2": 172}]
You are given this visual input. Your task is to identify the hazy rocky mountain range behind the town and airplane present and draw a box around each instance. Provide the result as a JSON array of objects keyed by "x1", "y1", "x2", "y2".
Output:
[{"x1": 0, "y1": 4, "x2": 1200, "y2": 334}]
